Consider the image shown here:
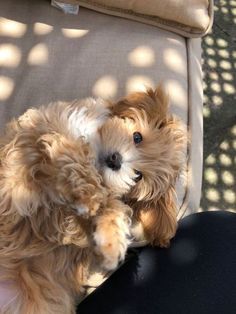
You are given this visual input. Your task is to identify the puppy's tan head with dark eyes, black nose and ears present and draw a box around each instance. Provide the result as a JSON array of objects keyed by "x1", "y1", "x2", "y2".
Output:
[{"x1": 100, "y1": 86, "x2": 186, "y2": 245}]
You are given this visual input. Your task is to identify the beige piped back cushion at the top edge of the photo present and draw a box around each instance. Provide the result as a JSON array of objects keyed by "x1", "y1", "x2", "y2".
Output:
[{"x1": 59, "y1": 0, "x2": 213, "y2": 37}]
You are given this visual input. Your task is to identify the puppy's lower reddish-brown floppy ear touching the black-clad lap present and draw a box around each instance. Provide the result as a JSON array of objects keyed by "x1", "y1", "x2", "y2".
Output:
[{"x1": 132, "y1": 187, "x2": 177, "y2": 247}]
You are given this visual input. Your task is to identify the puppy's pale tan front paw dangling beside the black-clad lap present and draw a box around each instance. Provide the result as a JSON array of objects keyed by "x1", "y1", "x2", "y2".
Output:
[{"x1": 94, "y1": 217, "x2": 130, "y2": 270}]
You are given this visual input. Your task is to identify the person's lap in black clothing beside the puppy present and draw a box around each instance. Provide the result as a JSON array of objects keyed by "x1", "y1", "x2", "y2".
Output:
[{"x1": 78, "y1": 212, "x2": 236, "y2": 314}]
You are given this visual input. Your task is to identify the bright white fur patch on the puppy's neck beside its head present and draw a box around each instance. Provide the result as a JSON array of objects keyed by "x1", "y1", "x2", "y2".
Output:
[{"x1": 68, "y1": 98, "x2": 110, "y2": 142}]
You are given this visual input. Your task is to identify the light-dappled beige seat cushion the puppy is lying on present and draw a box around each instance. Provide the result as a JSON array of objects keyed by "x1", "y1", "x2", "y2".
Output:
[{"x1": 0, "y1": 0, "x2": 202, "y2": 216}]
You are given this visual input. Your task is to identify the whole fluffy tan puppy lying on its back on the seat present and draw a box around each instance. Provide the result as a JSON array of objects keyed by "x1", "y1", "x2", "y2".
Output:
[{"x1": 0, "y1": 87, "x2": 186, "y2": 314}]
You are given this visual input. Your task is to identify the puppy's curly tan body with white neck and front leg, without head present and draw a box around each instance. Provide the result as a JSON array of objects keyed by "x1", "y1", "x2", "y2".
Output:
[{"x1": 0, "y1": 98, "x2": 133, "y2": 314}]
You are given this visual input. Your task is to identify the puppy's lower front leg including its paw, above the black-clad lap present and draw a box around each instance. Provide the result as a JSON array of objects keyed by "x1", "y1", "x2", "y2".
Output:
[{"x1": 93, "y1": 200, "x2": 131, "y2": 270}]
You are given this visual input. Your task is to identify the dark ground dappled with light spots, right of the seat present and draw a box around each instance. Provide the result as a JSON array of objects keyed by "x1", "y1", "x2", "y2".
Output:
[{"x1": 200, "y1": 0, "x2": 236, "y2": 211}]
